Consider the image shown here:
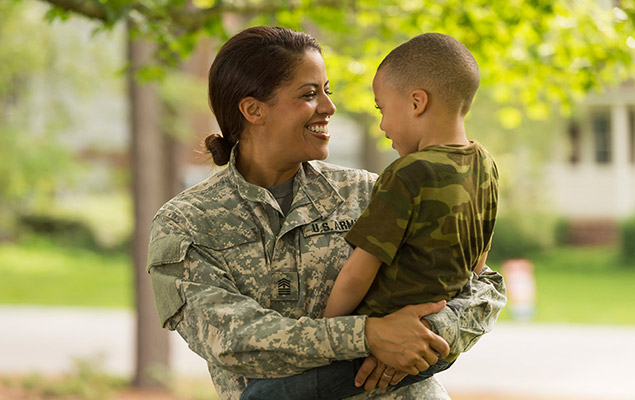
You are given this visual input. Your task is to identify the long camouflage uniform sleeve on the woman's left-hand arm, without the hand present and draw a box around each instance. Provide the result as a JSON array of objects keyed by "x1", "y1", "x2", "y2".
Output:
[{"x1": 148, "y1": 209, "x2": 369, "y2": 378}]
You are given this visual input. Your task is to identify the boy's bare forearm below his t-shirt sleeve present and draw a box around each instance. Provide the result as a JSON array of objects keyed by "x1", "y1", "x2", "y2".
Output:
[{"x1": 324, "y1": 247, "x2": 381, "y2": 318}]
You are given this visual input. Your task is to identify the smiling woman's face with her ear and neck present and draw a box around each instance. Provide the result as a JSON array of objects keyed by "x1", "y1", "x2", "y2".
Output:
[{"x1": 238, "y1": 50, "x2": 335, "y2": 187}]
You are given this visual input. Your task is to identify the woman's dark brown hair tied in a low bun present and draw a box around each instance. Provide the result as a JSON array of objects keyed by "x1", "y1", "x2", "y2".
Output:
[{"x1": 205, "y1": 26, "x2": 322, "y2": 165}]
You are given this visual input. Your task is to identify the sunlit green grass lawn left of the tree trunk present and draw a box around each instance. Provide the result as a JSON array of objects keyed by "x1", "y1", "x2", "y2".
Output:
[{"x1": 0, "y1": 237, "x2": 133, "y2": 308}]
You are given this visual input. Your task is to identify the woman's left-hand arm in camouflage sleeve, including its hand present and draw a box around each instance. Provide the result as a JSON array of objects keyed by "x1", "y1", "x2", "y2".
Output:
[{"x1": 149, "y1": 240, "x2": 448, "y2": 378}]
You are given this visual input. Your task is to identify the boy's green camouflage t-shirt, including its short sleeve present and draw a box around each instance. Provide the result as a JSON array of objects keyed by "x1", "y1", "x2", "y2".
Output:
[{"x1": 346, "y1": 142, "x2": 498, "y2": 316}]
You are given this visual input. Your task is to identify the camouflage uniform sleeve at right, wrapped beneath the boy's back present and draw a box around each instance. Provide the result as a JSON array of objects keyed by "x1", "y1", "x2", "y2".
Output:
[{"x1": 425, "y1": 266, "x2": 507, "y2": 354}]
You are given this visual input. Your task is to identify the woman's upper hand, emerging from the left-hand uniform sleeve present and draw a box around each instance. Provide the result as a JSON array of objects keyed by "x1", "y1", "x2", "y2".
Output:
[{"x1": 366, "y1": 301, "x2": 450, "y2": 376}]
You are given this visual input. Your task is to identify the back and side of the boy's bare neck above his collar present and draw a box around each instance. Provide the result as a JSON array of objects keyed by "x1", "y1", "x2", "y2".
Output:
[{"x1": 419, "y1": 111, "x2": 470, "y2": 150}]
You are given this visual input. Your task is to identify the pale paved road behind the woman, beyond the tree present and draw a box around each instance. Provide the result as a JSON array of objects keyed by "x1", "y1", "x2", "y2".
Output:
[{"x1": 0, "y1": 306, "x2": 635, "y2": 400}]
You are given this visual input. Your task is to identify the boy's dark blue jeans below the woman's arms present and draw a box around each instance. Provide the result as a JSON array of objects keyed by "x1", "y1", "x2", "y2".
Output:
[{"x1": 240, "y1": 358, "x2": 454, "y2": 400}]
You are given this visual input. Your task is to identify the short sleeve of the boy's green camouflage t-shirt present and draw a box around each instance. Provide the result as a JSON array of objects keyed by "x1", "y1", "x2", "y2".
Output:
[{"x1": 345, "y1": 167, "x2": 412, "y2": 264}]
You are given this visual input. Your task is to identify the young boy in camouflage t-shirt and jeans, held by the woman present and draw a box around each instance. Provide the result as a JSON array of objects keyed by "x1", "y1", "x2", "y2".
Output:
[{"x1": 241, "y1": 33, "x2": 498, "y2": 399}]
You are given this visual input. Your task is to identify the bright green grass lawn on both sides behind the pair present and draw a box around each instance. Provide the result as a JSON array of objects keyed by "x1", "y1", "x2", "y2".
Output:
[{"x1": 0, "y1": 237, "x2": 635, "y2": 325}]
